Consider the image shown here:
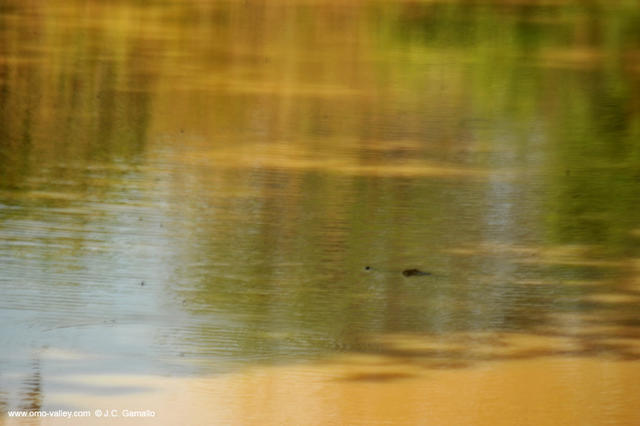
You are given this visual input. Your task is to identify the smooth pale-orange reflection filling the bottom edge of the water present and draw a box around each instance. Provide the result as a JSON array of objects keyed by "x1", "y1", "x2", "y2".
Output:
[{"x1": 44, "y1": 335, "x2": 640, "y2": 426}]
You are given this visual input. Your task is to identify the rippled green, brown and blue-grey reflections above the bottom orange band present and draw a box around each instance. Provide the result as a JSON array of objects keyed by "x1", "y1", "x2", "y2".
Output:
[{"x1": 0, "y1": 0, "x2": 640, "y2": 424}]
